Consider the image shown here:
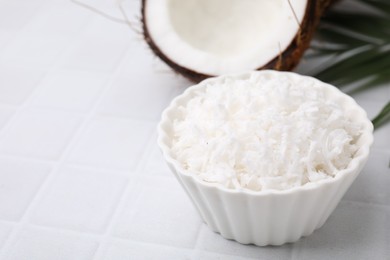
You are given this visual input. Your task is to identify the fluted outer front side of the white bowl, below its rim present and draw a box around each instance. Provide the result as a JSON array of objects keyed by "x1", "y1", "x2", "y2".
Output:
[{"x1": 171, "y1": 160, "x2": 358, "y2": 246}]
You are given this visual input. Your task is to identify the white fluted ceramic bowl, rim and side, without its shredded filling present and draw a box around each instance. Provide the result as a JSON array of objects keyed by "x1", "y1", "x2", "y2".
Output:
[{"x1": 158, "y1": 71, "x2": 373, "y2": 246}]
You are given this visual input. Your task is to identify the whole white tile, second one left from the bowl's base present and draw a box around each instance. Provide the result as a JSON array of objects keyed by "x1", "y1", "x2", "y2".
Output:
[{"x1": 29, "y1": 166, "x2": 128, "y2": 233}]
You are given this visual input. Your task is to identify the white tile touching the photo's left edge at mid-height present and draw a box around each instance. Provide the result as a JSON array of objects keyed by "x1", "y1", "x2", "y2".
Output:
[{"x1": 0, "y1": 108, "x2": 82, "y2": 160}]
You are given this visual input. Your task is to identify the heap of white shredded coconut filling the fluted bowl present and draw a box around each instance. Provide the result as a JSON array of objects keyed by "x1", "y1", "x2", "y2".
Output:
[{"x1": 171, "y1": 74, "x2": 361, "y2": 191}]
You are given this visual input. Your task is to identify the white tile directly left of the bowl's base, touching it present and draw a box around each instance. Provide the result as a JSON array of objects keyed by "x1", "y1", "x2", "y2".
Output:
[{"x1": 112, "y1": 177, "x2": 201, "y2": 248}]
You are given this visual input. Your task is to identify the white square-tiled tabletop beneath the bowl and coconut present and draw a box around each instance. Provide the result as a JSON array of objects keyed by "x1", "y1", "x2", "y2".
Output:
[{"x1": 0, "y1": 0, "x2": 390, "y2": 260}]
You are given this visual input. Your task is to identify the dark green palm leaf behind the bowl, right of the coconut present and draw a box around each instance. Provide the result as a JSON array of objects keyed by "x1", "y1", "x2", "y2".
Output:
[{"x1": 305, "y1": 0, "x2": 390, "y2": 128}]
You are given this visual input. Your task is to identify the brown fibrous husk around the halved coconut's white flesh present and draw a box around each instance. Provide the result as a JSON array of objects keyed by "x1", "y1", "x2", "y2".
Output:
[{"x1": 141, "y1": 0, "x2": 337, "y2": 82}]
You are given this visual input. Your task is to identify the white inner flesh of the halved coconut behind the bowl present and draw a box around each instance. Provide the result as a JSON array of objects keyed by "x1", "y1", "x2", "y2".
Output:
[{"x1": 145, "y1": 0, "x2": 307, "y2": 75}]
